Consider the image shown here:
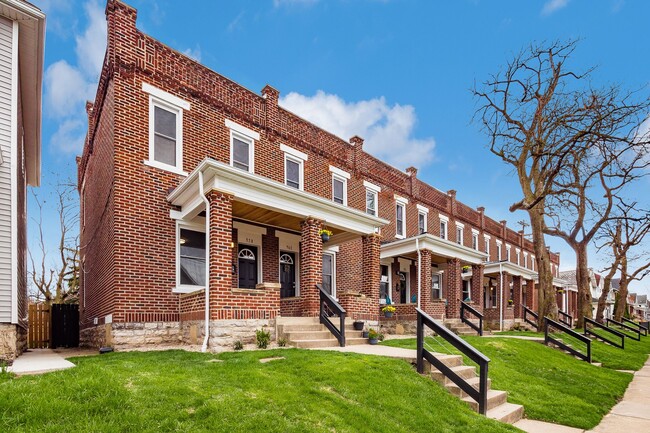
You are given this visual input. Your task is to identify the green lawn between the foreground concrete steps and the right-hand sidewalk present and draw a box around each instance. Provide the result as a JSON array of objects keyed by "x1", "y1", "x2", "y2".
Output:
[{"x1": 384, "y1": 333, "x2": 632, "y2": 429}]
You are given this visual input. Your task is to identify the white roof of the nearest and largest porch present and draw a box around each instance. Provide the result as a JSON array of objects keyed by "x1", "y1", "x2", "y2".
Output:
[{"x1": 167, "y1": 158, "x2": 388, "y2": 240}]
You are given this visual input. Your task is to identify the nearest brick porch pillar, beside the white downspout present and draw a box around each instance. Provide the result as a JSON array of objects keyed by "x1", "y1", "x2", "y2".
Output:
[{"x1": 206, "y1": 191, "x2": 232, "y2": 319}]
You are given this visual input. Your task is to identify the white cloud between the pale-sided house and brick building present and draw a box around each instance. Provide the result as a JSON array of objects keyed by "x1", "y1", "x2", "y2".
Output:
[{"x1": 44, "y1": 0, "x2": 106, "y2": 154}]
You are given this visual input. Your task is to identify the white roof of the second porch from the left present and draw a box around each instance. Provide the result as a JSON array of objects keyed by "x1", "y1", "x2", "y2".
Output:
[{"x1": 381, "y1": 233, "x2": 487, "y2": 264}]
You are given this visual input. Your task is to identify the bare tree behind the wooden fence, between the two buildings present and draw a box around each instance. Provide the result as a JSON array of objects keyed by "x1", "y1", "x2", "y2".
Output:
[{"x1": 29, "y1": 182, "x2": 79, "y2": 305}]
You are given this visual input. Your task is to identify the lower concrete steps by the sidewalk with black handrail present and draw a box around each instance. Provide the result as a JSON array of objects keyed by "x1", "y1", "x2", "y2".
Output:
[{"x1": 425, "y1": 353, "x2": 524, "y2": 424}]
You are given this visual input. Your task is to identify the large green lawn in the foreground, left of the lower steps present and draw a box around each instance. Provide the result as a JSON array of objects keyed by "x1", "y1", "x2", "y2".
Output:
[{"x1": 0, "y1": 349, "x2": 517, "y2": 433}]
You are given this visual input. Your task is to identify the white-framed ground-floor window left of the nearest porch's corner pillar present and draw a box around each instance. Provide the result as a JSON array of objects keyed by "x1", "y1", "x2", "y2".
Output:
[{"x1": 174, "y1": 222, "x2": 206, "y2": 293}]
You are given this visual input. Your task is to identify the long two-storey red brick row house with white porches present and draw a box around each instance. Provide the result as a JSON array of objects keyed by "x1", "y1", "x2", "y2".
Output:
[{"x1": 78, "y1": 0, "x2": 559, "y2": 346}]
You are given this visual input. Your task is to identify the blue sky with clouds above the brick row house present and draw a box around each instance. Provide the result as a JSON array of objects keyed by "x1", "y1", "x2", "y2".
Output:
[{"x1": 30, "y1": 0, "x2": 650, "y2": 291}]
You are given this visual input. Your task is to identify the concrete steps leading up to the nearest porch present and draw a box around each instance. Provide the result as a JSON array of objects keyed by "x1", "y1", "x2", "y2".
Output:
[{"x1": 276, "y1": 317, "x2": 368, "y2": 349}]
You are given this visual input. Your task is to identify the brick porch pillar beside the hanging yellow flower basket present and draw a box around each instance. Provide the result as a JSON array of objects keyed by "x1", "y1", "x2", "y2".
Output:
[{"x1": 300, "y1": 218, "x2": 323, "y2": 316}]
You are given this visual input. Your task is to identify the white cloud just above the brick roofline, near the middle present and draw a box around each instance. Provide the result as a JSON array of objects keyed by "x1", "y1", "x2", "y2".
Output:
[{"x1": 280, "y1": 91, "x2": 435, "y2": 168}]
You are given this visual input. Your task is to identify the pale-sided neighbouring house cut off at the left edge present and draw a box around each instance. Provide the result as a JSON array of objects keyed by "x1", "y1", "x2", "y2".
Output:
[{"x1": 0, "y1": 0, "x2": 45, "y2": 362}]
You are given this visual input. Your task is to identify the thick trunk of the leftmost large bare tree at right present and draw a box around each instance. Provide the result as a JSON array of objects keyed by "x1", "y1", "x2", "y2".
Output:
[{"x1": 528, "y1": 206, "x2": 557, "y2": 332}]
